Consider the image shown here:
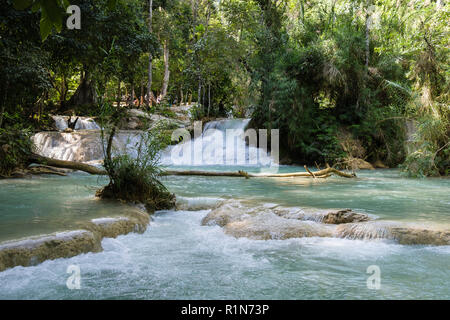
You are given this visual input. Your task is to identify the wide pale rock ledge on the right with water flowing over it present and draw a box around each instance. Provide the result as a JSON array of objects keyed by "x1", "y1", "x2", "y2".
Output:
[{"x1": 202, "y1": 200, "x2": 450, "y2": 245}]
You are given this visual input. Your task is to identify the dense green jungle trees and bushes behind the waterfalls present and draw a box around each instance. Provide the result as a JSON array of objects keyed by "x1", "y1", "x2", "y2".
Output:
[{"x1": 0, "y1": 0, "x2": 450, "y2": 176}]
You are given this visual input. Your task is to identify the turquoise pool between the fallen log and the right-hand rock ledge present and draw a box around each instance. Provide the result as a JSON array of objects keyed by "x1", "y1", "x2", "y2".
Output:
[{"x1": 166, "y1": 166, "x2": 450, "y2": 225}]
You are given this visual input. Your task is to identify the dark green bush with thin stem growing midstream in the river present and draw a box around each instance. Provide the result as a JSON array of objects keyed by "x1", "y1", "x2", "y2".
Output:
[{"x1": 97, "y1": 104, "x2": 175, "y2": 212}]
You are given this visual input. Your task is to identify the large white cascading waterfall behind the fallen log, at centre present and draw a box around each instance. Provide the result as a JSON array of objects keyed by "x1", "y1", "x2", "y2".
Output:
[{"x1": 161, "y1": 119, "x2": 272, "y2": 166}]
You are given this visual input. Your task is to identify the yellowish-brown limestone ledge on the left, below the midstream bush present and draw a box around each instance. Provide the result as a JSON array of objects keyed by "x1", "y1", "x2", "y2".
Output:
[{"x1": 0, "y1": 210, "x2": 150, "y2": 272}]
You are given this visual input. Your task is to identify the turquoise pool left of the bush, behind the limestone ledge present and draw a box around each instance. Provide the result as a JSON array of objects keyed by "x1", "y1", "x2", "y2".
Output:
[{"x1": 0, "y1": 174, "x2": 135, "y2": 241}]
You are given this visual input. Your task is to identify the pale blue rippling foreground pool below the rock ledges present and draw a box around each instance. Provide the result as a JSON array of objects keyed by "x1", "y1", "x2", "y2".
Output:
[{"x1": 0, "y1": 211, "x2": 450, "y2": 299}]
